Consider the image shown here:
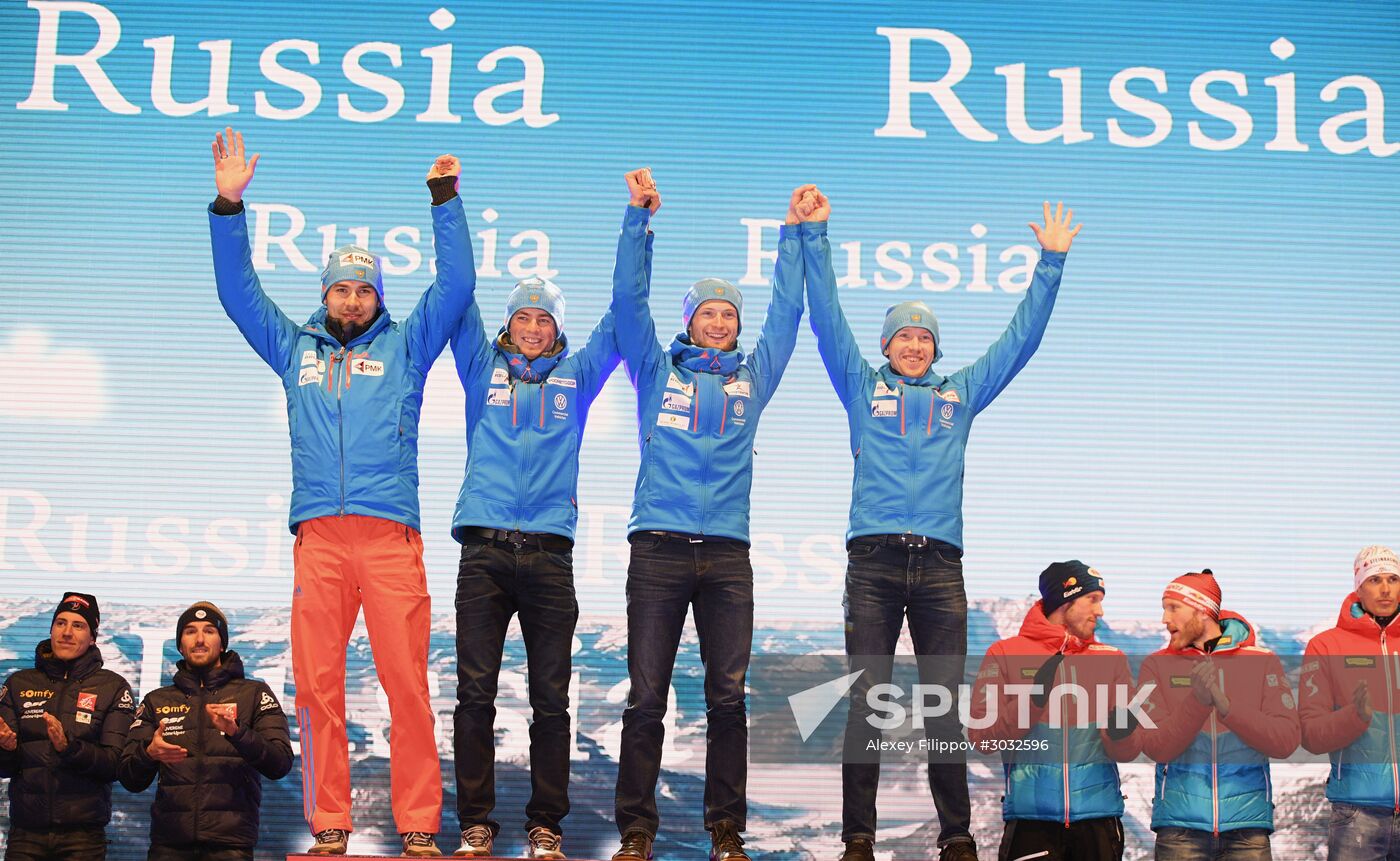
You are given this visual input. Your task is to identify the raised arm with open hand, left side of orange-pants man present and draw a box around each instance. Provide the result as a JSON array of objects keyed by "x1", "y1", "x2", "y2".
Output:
[{"x1": 209, "y1": 129, "x2": 297, "y2": 374}]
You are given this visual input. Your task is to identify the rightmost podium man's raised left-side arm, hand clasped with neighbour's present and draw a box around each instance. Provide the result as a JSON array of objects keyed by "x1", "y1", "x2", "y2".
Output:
[{"x1": 798, "y1": 186, "x2": 874, "y2": 405}]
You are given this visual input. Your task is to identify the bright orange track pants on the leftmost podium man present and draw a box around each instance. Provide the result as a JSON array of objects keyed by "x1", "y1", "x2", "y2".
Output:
[{"x1": 291, "y1": 514, "x2": 442, "y2": 834}]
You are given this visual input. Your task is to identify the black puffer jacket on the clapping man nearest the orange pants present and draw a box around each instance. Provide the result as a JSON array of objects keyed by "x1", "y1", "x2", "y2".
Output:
[{"x1": 119, "y1": 652, "x2": 291, "y2": 848}]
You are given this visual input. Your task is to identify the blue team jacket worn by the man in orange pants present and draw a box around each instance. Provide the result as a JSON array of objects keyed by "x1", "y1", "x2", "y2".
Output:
[{"x1": 209, "y1": 197, "x2": 476, "y2": 532}]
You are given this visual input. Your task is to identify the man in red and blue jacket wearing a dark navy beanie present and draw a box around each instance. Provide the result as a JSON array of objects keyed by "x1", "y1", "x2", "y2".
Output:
[{"x1": 967, "y1": 559, "x2": 1138, "y2": 861}]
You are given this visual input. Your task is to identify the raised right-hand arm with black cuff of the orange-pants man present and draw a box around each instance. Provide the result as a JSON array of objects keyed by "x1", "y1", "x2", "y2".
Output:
[{"x1": 403, "y1": 155, "x2": 476, "y2": 374}]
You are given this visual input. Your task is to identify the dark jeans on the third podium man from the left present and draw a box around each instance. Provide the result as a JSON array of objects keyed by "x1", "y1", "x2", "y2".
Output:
[{"x1": 616, "y1": 532, "x2": 753, "y2": 834}]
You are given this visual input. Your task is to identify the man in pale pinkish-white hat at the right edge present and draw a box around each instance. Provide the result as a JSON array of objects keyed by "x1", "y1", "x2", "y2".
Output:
[{"x1": 1298, "y1": 545, "x2": 1400, "y2": 861}]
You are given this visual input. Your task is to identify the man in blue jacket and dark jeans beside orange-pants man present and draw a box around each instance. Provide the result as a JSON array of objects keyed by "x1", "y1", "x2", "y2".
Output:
[{"x1": 452, "y1": 266, "x2": 617, "y2": 858}]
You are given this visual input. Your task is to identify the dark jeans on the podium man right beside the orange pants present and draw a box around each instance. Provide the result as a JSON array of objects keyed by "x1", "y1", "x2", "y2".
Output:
[{"x1": 452, "y1": 536, "x2": 578, "y2": 833}]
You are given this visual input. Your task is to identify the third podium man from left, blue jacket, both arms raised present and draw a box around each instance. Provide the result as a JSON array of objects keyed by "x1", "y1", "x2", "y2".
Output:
[{"x1": 612, "y1": 169, "x2": 802, "y2": 861}]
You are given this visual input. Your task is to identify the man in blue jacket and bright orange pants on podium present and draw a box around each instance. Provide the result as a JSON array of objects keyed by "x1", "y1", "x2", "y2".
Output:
[{"x1": 209, "y1": 129, "x2": 476, "y2": 857}]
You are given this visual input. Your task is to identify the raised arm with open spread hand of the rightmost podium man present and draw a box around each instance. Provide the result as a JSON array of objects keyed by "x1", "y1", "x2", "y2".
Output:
[{"x1": 960, "y1": 203, "x2": 1084, "y2": 413}]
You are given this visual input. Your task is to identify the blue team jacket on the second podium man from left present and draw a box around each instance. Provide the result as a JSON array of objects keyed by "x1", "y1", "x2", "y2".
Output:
[{"x1": 452, "y1": 289, "x2": 635, "y2": 540}]
